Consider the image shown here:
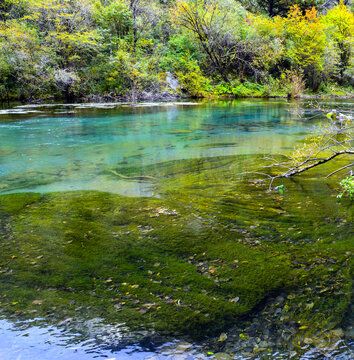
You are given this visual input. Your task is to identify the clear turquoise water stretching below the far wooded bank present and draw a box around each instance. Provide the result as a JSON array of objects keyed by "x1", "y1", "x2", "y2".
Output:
[{"x1": 0, "y1": 100, "x2": 314, "y2": 196}]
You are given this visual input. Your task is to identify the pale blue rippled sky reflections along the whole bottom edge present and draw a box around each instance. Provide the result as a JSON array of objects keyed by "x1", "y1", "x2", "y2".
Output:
[{"x1": 0, "y1": 319, "x2": 354, "y2": 360}]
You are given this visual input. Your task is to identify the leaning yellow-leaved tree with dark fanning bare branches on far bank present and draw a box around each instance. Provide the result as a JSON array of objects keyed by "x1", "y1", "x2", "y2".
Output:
[{"x1": 172, "y1": 0, "x2": 272, "y2": 82}]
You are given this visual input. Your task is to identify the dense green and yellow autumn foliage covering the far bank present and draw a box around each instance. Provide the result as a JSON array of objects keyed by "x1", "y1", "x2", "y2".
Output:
[{"x1": 0, "y1": 0, "x2": 354, "y2": 101}]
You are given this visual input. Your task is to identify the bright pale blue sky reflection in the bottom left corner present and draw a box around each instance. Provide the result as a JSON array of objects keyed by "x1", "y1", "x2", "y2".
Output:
[{"x1": 0, "y1": 320, "x2": 160, "y2": 360}]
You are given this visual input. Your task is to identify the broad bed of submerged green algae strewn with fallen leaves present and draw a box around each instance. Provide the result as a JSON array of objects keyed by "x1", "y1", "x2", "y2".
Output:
[{"x1": 0, "y1": 156, "x2": 352, "y2": 348}]
